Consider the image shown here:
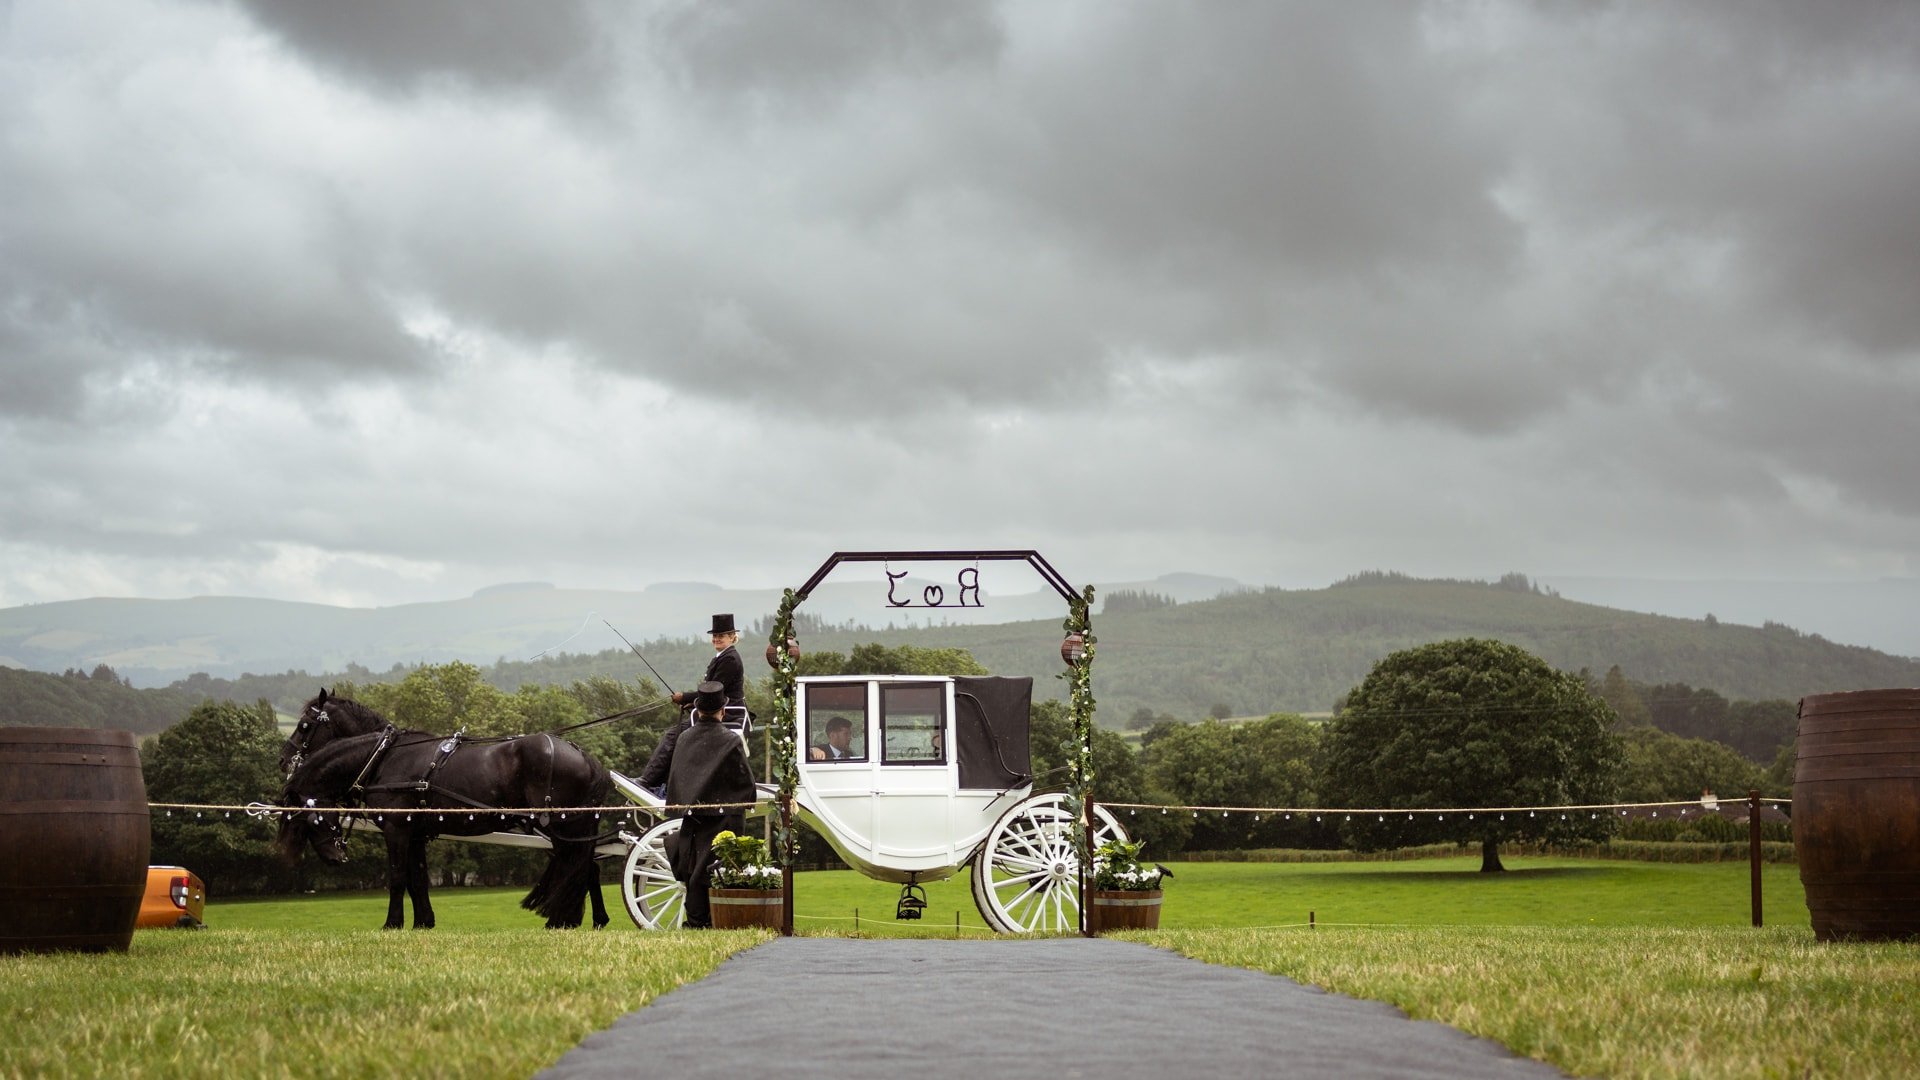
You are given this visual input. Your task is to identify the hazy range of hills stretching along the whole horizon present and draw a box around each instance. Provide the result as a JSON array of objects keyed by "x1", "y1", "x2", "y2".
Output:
[{"x1": 0, "y1": 575, "x2": 1920, "y2": 724}]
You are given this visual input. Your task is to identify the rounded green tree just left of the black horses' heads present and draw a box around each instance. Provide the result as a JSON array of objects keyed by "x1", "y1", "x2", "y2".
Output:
[{"x1": 140, "y1": 701, "x2": 282, "y2": 896}]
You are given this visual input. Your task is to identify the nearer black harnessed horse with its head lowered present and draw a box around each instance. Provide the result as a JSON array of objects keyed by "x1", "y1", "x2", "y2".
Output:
[{"x1": 275, "y1": 726, "x2": 612, "y2": 930}]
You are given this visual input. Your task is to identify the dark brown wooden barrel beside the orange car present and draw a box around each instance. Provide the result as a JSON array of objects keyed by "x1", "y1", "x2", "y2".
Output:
[{"x1": 0, "y1": 728, "x2": 152, "y2": 953}]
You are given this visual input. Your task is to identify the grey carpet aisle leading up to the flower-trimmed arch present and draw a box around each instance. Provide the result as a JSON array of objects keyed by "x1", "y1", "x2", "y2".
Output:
[{"x1": 541, "y1": 938, "x2": 1561, "y2": 1080}]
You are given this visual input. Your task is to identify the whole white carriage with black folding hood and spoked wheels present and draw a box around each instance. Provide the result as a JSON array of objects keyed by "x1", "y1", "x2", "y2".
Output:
[{"x1": 599, "y1": 675, "x2": 1125, "y2": 934}]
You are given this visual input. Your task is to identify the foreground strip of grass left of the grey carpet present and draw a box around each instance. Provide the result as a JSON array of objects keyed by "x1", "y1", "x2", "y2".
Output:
[{"x1": 0, "y1": 926, "x2": 766, "y2": 1078}]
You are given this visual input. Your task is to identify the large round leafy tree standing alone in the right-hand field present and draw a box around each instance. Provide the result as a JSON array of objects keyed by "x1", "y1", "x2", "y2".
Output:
[{"x1": 1321, "y1": 638, "x2": 1624, "y2": 871}]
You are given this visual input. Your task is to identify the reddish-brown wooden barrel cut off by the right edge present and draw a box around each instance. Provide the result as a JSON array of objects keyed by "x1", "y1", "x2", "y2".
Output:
[{"x1": 1793, "y1": 690, "x2": 1920, "y2": 942}]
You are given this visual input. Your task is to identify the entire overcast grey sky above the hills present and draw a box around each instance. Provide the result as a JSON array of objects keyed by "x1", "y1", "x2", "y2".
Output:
[{"x1": 0, "y1": 0, "x2": 1920, "y2": 605}]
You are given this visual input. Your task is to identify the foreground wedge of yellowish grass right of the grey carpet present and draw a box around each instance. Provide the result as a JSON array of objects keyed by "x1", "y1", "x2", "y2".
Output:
[{"x1": 1121, "y1": 926, "x2": 1920, "y2": 1080}]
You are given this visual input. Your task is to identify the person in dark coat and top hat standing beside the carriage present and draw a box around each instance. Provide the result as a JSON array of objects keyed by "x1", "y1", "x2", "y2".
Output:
[{"x1": 666, "y1": 682, "x2": 756, "y2": 928}]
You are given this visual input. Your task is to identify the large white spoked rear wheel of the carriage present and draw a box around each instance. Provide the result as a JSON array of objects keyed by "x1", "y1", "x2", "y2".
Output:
[{"x1": 972, "y1": 792, "x2": 1127, "y2": 934}]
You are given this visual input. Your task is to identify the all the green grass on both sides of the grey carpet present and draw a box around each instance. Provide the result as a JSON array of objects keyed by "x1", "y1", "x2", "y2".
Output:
[{"x1": 11, "y1": 859, "x2": 1920, "y2": 1076}]
